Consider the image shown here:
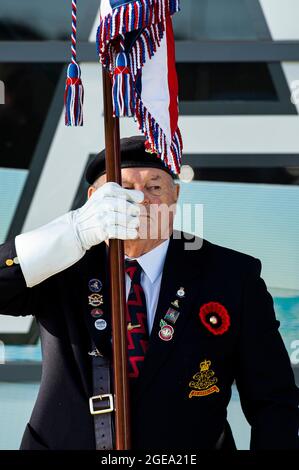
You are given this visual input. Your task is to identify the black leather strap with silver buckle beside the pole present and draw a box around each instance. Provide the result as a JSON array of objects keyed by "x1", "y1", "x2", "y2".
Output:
[{"x1": 89, "y1": 348, "x2": 114, "y2": 450}]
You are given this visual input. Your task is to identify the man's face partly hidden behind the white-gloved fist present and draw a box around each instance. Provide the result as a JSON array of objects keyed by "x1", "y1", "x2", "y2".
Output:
[{"x1": 89, "y1": 167, "x2": 179, "y2": 242}]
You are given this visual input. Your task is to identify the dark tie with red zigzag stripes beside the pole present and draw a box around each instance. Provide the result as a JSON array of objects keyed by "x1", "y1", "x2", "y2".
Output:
[{"x1": 125, "y1": 260, "x2": 149, "y2": 379}]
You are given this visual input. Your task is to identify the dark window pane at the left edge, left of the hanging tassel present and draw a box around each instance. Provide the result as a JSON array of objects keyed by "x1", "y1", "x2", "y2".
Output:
[{"x1": 0, "y1": 63, "x2": 63, "y2": 168}]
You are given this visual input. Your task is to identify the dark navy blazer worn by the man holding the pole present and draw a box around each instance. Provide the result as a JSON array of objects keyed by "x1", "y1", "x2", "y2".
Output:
[{"x1": 0, "y1": 232, "x2": 299, "y2": 450}]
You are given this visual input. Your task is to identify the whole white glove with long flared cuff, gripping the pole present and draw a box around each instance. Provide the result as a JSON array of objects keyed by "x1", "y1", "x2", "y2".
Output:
[{"x1": 15, "y1": 183, "x2": 144, "y2": 287}]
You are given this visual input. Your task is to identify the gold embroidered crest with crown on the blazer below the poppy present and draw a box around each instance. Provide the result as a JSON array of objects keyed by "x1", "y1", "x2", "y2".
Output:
[{"x1": 189, "y1": 359, "x2": 220, "y2": 398}]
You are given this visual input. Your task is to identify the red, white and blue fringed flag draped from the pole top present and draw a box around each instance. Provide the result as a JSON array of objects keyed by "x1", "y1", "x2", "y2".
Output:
[{"x1": 97, "y1": 0, "x2": 183, "y2": 174}]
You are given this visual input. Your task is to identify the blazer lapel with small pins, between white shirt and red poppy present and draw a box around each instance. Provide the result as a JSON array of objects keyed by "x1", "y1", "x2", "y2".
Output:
[{"x1": 136, "y1": 234, "x2": 211, "y2": 398}]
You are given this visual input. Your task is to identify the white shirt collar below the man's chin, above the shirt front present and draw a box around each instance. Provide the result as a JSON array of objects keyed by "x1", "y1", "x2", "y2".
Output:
[{"x1": 126, "y1": 238, "x2": 169, "y2": 284}]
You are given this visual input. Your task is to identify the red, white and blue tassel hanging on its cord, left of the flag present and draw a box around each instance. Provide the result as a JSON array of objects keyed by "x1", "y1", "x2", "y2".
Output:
[{"x1": 64, "y1": 0, "x2": 84, "y2": 126}]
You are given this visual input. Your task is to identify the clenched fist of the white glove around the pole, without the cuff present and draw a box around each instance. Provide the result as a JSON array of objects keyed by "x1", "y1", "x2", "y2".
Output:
[{"x1": 72, "y1": 183, "x2": 144, "y2": 250}]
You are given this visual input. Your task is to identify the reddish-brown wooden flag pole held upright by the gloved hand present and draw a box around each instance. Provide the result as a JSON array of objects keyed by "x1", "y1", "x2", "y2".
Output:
[{"x1": 102, "y1": 69, "x2": 131, "y2": 450}]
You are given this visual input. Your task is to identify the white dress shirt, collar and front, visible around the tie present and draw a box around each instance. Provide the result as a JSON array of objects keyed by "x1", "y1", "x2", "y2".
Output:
[{"x1": 125, "y1": 239, "x2": 169, "y2": 333}]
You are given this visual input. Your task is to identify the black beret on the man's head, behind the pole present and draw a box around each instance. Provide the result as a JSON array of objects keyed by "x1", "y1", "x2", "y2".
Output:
[{"x1": 85, "y1": 136, "x2": 176, "y2": 184}]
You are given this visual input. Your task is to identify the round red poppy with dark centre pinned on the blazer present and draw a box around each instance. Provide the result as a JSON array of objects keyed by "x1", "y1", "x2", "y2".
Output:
[{"x1": 199, "y1": 302, "x2": 230, "y2": 336}]
